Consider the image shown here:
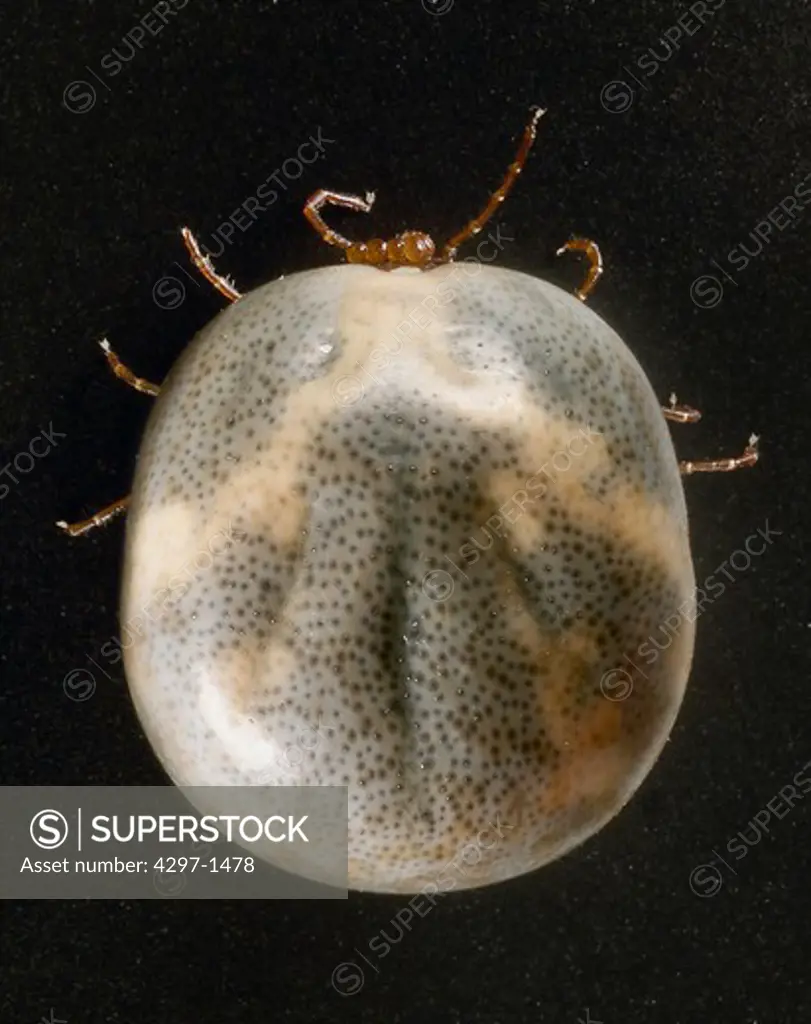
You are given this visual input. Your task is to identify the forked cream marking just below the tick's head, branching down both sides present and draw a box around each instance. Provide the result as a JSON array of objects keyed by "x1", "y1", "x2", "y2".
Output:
[{"x1": 204, "y1": 268, "x2": 605, "y2": 544}]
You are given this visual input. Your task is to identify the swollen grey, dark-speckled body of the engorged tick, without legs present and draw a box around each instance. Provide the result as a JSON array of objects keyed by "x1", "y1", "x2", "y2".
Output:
[{"x1": 122, "y1": 263, "x2": 694, "y2": 891}]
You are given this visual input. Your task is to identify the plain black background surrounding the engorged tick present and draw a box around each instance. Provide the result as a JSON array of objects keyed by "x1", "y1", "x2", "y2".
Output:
[{"x1": 0, "y1": 0, "x2": 811, "y2": 1024}]
